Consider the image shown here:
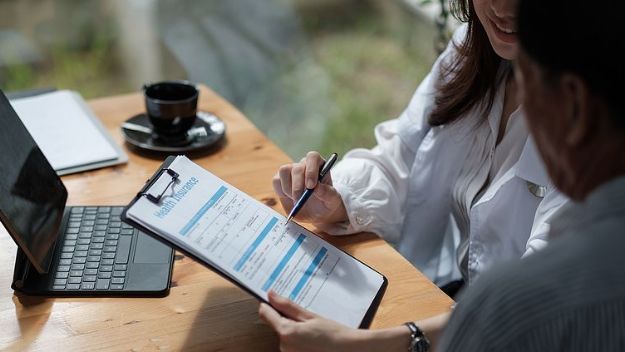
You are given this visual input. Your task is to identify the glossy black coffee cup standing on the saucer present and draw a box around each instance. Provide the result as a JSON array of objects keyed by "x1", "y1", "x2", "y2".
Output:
[{"x1": 143, "y1": 81, "x2": 200, "y2": 138}]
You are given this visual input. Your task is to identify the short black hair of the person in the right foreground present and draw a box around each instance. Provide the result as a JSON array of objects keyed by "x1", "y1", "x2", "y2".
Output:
[{"x1": 518, "y1": 0, "x2": 625, "y2": 128}]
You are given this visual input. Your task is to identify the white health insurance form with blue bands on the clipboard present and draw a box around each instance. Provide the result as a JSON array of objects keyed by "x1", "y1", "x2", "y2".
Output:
[{"x1": 126, "y1": 156, "x2": 385, "y2": 327}]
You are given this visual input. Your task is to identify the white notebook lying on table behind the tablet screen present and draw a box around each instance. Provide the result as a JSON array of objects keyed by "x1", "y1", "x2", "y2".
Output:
[{"x1": 11, "y1": 90, "x2": 128, "y2": 175}]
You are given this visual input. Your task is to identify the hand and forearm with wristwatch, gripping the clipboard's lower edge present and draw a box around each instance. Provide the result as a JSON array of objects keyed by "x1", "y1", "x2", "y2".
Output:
[{"x1": 258, "y1": 291, "x2": 410, "y2": 352}]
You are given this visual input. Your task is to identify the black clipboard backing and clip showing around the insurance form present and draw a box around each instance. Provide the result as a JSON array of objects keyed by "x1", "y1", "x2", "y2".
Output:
[{"x1": 121, "y1": 155, "x2": 388, "y2": 329}]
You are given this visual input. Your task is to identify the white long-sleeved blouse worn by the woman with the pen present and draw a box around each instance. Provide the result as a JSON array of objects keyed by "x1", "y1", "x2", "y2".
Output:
[{"x1": 317, "y1": 25, "x2": 567, "y2": 285}]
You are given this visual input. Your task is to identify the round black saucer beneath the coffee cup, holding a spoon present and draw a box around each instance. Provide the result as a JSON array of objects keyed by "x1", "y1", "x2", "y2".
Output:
[{"x1": 121, "y1": 111, "x2": 226, "y2": 154}]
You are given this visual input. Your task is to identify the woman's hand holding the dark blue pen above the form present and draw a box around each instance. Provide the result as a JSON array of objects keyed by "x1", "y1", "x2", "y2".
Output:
[{"x1": 273, "y1": 152, "x2": 348, "y2": 224}]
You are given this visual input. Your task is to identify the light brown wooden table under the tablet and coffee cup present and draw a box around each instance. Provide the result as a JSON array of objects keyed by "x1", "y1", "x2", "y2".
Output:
[{"x1": 0, "y1": 87, "x2": 453, "y2": 351}]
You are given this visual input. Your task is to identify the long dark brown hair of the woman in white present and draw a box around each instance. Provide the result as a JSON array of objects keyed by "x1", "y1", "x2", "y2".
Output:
[{"x1": 428, "y1": 0, "x2": 505, "y2": 126}]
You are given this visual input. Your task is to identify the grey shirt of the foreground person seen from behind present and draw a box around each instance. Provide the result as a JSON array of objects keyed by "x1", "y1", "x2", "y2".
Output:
[{"x1": 440, "y1": 177, "x2": 625, "y2": 352}]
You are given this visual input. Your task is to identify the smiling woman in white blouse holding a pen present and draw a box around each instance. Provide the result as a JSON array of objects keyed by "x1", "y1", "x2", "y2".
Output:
[{"x1": 273, "y1": 0, "x2": 565, "y2": 295}]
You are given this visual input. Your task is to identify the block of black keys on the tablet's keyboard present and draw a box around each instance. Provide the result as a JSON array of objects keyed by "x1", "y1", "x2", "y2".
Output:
[{"x1": 52, "y1": 206, "x2": 136, "y2": 291}]
